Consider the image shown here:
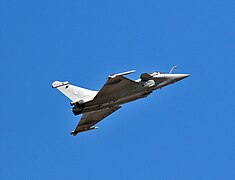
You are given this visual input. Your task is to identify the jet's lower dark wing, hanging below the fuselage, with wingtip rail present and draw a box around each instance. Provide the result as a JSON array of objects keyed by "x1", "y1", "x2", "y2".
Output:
[{"x1": 70, "y1": 106, "x2": 121, "y2": 136}]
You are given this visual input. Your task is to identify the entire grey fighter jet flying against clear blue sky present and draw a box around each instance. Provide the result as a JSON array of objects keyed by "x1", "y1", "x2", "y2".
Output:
[{"x1": 52, "y1": 66, "x2": 189, "y2": 136}]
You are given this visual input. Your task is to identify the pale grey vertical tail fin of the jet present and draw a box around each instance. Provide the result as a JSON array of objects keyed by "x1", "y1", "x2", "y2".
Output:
[{"x1": 52, "y1": 81, "x2": 97, "y2": 102}]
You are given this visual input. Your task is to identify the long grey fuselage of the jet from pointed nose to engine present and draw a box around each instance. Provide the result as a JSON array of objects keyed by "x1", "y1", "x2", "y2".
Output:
[{"x1": 82, "y1": 74, "x2": 189, "y2": 113}]
